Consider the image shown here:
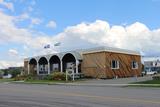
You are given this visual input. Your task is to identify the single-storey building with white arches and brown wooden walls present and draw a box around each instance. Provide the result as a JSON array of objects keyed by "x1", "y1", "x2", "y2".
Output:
[{"x1": 24, "y1": 47, "x2": 141, "y2": 78}]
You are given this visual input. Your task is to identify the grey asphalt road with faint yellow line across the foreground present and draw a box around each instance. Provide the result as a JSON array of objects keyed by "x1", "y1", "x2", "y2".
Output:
[{"x1": 0, "y1": 83, "x2": 160, "y2": 107}]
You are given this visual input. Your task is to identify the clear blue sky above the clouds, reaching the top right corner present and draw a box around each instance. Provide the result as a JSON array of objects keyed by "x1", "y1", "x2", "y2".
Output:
[{"x1": 8, "y1": 0, "x2": 160, "y2": 34}]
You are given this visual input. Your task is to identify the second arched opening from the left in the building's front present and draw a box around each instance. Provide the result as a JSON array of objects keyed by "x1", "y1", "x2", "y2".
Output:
[{"x1": 38, "y1": 57, "x2": 48, "y2": 74}]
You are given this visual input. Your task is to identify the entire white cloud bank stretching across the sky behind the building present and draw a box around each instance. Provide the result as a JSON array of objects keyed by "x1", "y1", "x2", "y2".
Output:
[{"x1": 0, "y1": 8, "x2": 160, "y2": 68}]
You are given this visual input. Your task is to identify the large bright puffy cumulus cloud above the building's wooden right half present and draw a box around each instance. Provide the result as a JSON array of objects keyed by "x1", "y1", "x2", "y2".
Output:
[{"x1": 51, "y1": 20, "x2": 160, "y2": 55}]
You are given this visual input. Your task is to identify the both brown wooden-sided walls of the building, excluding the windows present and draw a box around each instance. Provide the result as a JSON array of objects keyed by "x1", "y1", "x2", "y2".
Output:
[{"x1": 81, "y1": 52, "x2": 141, "y2": 78}]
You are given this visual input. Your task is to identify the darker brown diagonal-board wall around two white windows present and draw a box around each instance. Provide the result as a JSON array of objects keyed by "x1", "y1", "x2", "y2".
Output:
[{"x1": 105, "y1": 52, "x2": 141, "y2": 78}]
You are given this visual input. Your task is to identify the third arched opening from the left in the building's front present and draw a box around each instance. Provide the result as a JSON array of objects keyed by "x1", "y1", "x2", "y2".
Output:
[{"x1": 49, "y1": 55, "x2": 61, "y2": 73}]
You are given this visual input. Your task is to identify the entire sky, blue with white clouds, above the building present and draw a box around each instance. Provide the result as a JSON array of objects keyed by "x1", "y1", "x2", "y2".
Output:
[{"x1": 0, "y1": 0, "x2": 160, "y2": 69}]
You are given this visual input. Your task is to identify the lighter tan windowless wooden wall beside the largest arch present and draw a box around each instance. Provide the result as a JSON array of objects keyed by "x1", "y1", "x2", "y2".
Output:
[{"x1": 81, "y1": 52, "x2": 106, "y2": 78}]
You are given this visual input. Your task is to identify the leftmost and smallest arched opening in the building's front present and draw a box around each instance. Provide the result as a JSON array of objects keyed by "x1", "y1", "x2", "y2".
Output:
[{"x1": 29, "y1": 58, "x2": 37, "y2": 75}]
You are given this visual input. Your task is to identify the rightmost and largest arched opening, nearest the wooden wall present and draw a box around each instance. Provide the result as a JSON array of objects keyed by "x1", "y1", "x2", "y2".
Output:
[{"x1": 62, "y1": 53, "x2": 76, "y2": 72}]
